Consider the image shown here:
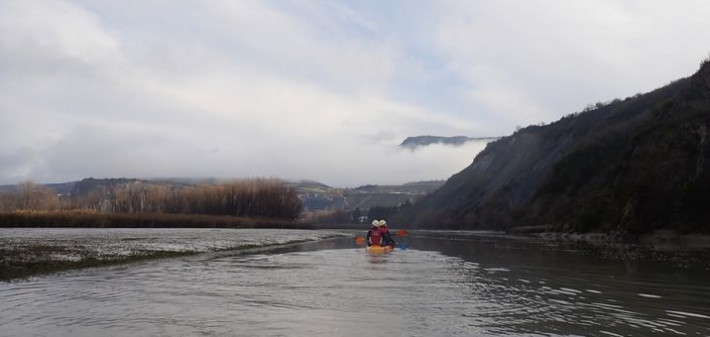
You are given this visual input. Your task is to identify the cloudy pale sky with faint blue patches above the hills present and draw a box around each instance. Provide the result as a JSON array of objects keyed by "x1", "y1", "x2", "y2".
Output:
[{"x1": 0, "y1": 0, "x2": 710, "y2": 187}]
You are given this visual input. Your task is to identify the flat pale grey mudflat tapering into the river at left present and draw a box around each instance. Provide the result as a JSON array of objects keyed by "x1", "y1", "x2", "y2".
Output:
[{"x1": 0, "y1": 228, "x2": 350, "y2": 281}]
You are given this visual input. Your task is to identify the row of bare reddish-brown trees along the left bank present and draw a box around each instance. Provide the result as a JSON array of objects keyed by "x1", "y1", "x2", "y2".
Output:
[{"x1": 0, "y1": 179, "x2": 302, "y2": 219}]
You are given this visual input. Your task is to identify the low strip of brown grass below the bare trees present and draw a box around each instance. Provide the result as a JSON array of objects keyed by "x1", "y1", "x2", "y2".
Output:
[{"x1": 0, "y1": 211, "x2": 315, "y2": 229}]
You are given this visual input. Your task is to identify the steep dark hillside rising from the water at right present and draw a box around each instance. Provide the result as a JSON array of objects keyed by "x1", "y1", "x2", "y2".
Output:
[{"x1": 398, "y1": 60, "x2": 710, "y2": 236}]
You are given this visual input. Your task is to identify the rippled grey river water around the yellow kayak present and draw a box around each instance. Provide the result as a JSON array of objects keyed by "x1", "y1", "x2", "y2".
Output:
[{"x1": 0, "y1": 232, "x2": 710, "y2": 336}]
